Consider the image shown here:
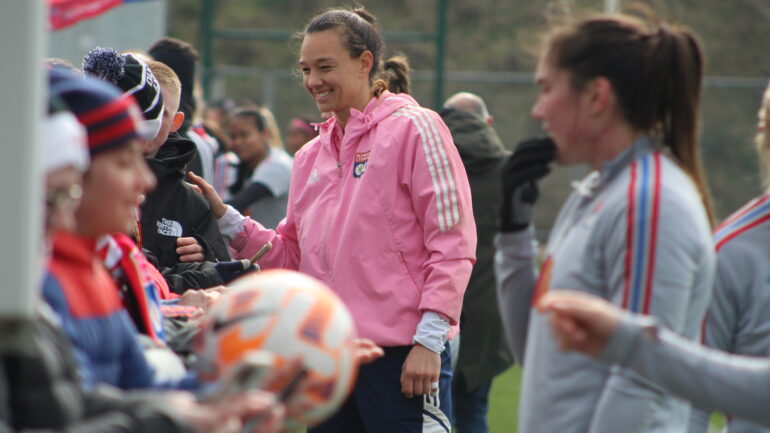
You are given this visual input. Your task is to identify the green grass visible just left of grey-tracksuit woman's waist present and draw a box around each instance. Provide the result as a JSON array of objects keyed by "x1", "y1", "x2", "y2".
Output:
[{"x1": 489, "y1": 367, "x2": 724, "y2": 433}]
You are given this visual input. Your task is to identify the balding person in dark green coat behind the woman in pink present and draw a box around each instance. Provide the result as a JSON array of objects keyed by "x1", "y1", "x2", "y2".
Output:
[{"x1": 440, "y1": 92, "x2": 513, "y2": 433}]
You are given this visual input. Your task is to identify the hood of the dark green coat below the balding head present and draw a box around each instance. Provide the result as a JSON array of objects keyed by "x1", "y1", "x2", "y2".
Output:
[{"x1": 439, "y1": 108, "x2": 509, "y2": 173}]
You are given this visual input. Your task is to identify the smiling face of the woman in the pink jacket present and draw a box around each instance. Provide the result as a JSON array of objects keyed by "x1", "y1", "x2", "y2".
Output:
[{"x1": 299, "y1": 29, "x2": 372, "y2": 124}]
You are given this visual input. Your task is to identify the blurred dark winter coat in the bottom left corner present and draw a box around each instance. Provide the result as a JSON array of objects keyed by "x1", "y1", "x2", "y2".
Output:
[{"x1": 0, "y1": 308, "x2": 192, "y2": 433}]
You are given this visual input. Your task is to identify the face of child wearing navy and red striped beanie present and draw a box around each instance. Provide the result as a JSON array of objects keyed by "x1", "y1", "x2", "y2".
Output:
[{"x1": 75, "y1": 140, "x2": 155, "y2": 237}]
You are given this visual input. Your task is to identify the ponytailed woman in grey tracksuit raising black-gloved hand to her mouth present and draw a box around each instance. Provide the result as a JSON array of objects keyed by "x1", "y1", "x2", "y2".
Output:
[{"x1": 496, "y1": 11, "x2": 715, "y2": 433}]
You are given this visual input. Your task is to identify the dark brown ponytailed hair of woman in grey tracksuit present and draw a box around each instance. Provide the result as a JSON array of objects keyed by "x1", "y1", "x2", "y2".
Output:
[{"x1": 546, "y1": 15, "x2": 714, "y2": 224}]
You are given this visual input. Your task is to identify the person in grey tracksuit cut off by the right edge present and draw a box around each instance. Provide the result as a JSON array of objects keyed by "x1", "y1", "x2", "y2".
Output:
[{"x1": 690, "y1": 81, "x2": 770, "y2": 433}]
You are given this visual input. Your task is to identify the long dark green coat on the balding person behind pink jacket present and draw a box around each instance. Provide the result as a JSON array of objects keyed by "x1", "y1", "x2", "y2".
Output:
[{"x1": 441, "y1": 110, "x2": 513, "y2": 390}]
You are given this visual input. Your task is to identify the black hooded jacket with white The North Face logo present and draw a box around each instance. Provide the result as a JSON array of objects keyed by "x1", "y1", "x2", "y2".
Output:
[{"x1": 140, "y1": 134, "x2": 230, "y2": 268}]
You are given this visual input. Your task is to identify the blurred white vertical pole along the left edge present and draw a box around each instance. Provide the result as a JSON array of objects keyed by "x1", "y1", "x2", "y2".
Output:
[{"x1": 0, "y1": 0, "x2": 47, "y2": 320}]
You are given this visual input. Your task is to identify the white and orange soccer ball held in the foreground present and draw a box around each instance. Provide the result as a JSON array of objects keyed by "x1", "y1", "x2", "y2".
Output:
[{"x1": 195, "y1": 270, "x2": 358, "y2": 429}]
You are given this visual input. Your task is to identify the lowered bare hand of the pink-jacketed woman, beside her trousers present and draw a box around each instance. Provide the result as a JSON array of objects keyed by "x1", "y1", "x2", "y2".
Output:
[{"x1": 401, "y1": 344, "x2": 441, "y2": 398}]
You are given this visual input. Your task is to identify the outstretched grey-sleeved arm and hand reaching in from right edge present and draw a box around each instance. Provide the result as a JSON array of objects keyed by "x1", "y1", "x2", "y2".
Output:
[{"x1": 538, "y1": 291, "x2": 770, "y2": 426}]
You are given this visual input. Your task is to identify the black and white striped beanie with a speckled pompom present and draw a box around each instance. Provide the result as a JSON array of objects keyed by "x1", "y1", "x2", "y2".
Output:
[{"x1": 83, "y1": 47, "x2": 163, "y2": 136}]
